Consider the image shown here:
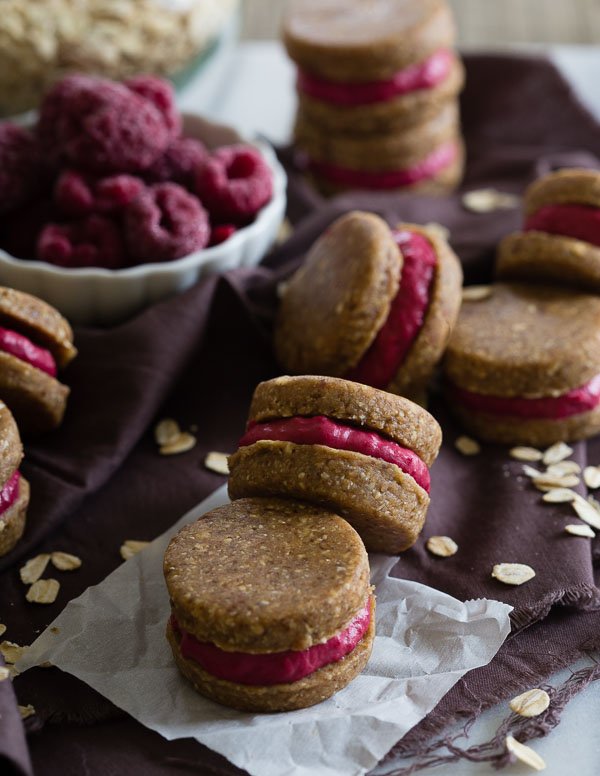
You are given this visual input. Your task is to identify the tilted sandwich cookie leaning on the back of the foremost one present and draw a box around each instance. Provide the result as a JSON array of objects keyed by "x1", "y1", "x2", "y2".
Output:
[{"x1": 229, "y1": 376, "x2": 441, "y2": 553}]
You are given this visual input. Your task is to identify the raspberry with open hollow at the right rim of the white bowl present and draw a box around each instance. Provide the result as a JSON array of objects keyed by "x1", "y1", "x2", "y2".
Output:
[{"x1": 196, "y1": 145, "x2": 273, "y2": 223}]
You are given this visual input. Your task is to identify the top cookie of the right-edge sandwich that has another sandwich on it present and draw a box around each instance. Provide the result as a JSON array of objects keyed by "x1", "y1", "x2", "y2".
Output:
[{"x1": 444, "y1": 283, "x2": 600, "y2": 398}]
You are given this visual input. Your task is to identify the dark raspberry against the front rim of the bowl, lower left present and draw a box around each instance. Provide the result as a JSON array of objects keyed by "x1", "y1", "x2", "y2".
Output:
[{"x1": 37, "y1": 215, "x2": 125, "y2": 269}]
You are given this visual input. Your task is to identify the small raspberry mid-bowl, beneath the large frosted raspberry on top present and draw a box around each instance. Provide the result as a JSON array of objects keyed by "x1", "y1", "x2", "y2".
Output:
[{"x1": 54, "y1": 170, "x2": 144, "y2": 217}]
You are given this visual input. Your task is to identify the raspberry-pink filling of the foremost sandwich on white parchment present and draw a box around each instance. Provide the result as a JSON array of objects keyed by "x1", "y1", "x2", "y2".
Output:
[{"x1": 171, "y1": 598, "x2": 372, "y2": 686}]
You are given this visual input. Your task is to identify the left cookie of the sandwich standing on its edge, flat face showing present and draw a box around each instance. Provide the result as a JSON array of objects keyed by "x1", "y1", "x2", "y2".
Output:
[{"x1": 275, "y1": 211, "x2": 402, "y2": 375}]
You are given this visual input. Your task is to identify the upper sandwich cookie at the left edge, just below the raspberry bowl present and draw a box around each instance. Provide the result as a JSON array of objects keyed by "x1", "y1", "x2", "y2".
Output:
[{"x1": 0, "y1": 288, "x2": 77, "y2": 433}]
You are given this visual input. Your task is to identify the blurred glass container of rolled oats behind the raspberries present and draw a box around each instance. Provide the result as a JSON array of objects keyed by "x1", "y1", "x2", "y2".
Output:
[{"x1": 0, "y1": 0, "x2": 239, "y2": 117}]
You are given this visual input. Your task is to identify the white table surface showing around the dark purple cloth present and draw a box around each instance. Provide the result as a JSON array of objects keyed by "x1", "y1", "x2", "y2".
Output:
[{"x1": 180, "y1": 40, "x2": 600, "y2": 776}]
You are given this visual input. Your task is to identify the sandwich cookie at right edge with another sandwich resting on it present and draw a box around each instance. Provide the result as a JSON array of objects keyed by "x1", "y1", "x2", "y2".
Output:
[{"x1": 444, "y1": 283, "x2": 600, "y2": 446}]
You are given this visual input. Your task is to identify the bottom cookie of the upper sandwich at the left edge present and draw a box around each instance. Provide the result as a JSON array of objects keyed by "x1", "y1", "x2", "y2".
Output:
[{"x1": 0, "y1": 351, "x2": 69, "y2": 434}]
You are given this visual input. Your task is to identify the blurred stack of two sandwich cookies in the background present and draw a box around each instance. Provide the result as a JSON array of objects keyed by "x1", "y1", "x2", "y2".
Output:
[{"x1": 283, "y1": 0, "x2": 464, "y2": 193}]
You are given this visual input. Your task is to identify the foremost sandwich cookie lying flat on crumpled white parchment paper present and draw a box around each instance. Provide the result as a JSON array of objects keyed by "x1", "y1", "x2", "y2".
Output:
[{"x1": 164, "y1": 499, "x2": 375, "y2": 712}]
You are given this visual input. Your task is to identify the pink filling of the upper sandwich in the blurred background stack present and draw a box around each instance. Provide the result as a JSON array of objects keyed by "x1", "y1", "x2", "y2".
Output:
[{"x1": 297, "y1": 49, "x2": 454, "y2": 106}]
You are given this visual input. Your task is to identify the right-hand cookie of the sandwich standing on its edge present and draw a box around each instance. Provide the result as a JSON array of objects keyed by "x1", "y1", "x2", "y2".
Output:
[{"x1": 388, "y1": 224, "x2": 463, "y2": 397}]
